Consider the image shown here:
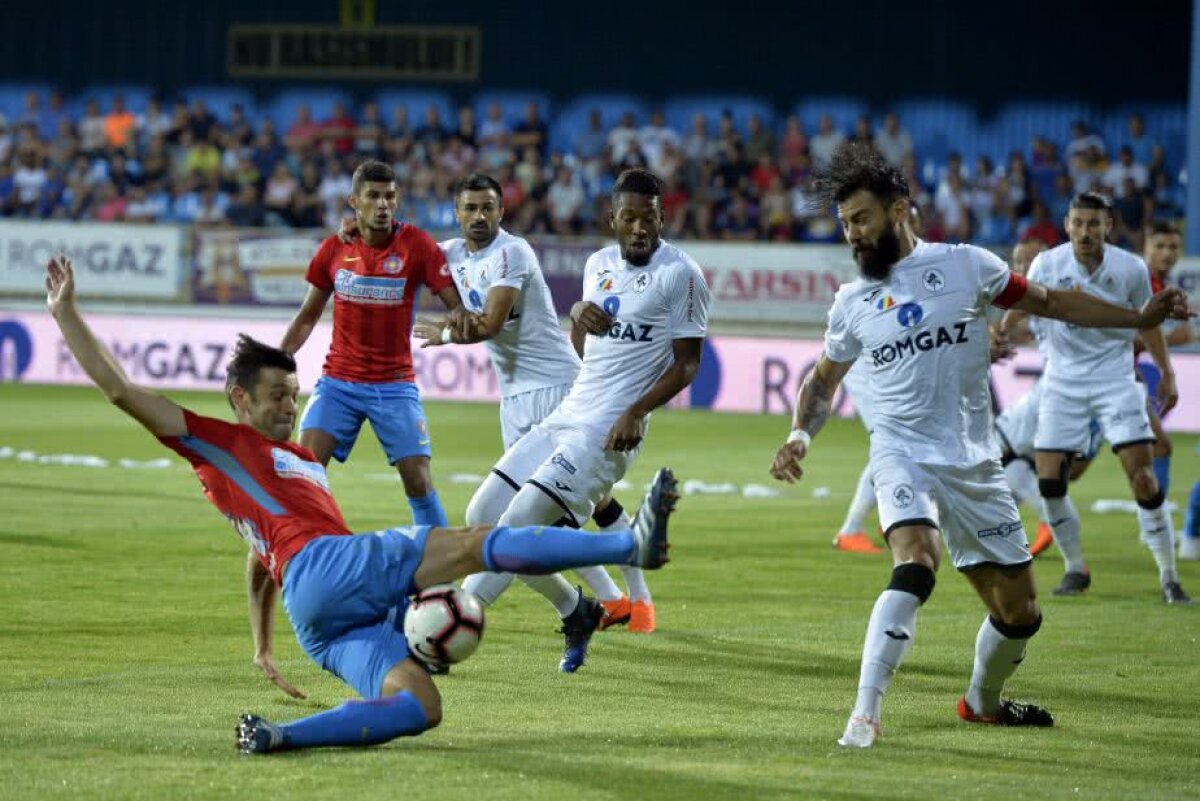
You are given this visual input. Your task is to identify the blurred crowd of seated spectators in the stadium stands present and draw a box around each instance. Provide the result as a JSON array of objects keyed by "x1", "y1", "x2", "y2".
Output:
[{"x1": 0, "y1": 92, "x2": 1183, "y2": 248}]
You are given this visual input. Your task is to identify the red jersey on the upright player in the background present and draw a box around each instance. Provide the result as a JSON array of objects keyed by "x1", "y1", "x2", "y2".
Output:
[{"x1": 306, "y1": 223, "x2": 454, "y2": 384}]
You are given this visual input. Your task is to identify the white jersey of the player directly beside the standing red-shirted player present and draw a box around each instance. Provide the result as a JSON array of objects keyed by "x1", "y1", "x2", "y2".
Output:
[{"x1": 440, "y1": 229, "x2": 580, "y2": 397}]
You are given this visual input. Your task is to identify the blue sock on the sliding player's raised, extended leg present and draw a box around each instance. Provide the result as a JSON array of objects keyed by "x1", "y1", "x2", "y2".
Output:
[{"x1": 484, "y1": 525, "x2": 637, "y2": 576}]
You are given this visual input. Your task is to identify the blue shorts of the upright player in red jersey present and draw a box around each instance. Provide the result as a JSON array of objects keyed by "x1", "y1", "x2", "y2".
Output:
[{"x1": 300, "y1": 375, "x2": 432, "y2": 464}]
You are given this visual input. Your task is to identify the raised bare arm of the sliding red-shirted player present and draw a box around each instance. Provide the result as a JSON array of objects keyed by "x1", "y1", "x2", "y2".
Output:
[{"x1": 46, "y1": 255, "x2": 187, "y2": 436}]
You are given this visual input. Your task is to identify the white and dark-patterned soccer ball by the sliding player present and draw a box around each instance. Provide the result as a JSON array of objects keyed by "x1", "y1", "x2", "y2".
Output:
[{"x1": 404, "y1": 584, "x2": 484, "y2": 666}]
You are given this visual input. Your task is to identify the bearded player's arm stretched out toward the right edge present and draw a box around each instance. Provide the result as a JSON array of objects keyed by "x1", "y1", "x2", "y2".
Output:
[{"x1": 1006, "y1": 281, "x2": 1192, "y2": 329}]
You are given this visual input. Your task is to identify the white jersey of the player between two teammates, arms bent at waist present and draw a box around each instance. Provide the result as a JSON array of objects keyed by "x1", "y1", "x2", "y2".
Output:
[{"x1": 546, "y1": 242, "x2": 708, "y2": 436}]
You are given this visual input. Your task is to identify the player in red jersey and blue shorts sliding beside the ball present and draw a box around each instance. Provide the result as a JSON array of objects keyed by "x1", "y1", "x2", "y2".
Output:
[{"x1": 46, "y1": 257, "x2": 676, "y2": 754}]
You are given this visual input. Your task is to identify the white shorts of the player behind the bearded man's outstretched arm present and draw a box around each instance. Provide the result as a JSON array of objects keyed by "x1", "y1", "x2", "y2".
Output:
[{"x1": 1034, "y1": 381, "x2": 1154, "y2": 453}]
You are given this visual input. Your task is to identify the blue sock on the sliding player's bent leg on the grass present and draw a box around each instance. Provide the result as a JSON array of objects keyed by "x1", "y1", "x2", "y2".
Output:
[{"x1": 280, "y1": 692, "x2": 430, "y2": 748}]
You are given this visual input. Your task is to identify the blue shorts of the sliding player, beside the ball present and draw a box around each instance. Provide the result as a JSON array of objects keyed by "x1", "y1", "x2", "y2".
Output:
[{"x1": 283, "y1": 525, "x2": 430, "y2": 698}]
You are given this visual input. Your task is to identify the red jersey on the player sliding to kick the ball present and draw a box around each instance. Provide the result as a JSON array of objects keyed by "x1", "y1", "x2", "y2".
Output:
[{"x1": 160, "y1": 409, "x2": 350, "y2": 583}]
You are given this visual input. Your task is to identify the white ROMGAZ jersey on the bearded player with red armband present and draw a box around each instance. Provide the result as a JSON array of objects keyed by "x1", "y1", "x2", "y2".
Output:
[{"x1": 826, "y1": 241, "x2": 1025, "y2": 466}]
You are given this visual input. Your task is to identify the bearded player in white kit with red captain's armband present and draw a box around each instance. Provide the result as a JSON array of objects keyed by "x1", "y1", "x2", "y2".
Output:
[{"x1": 770, "y1": 145, "x2": 1188, "y2": 748}]
